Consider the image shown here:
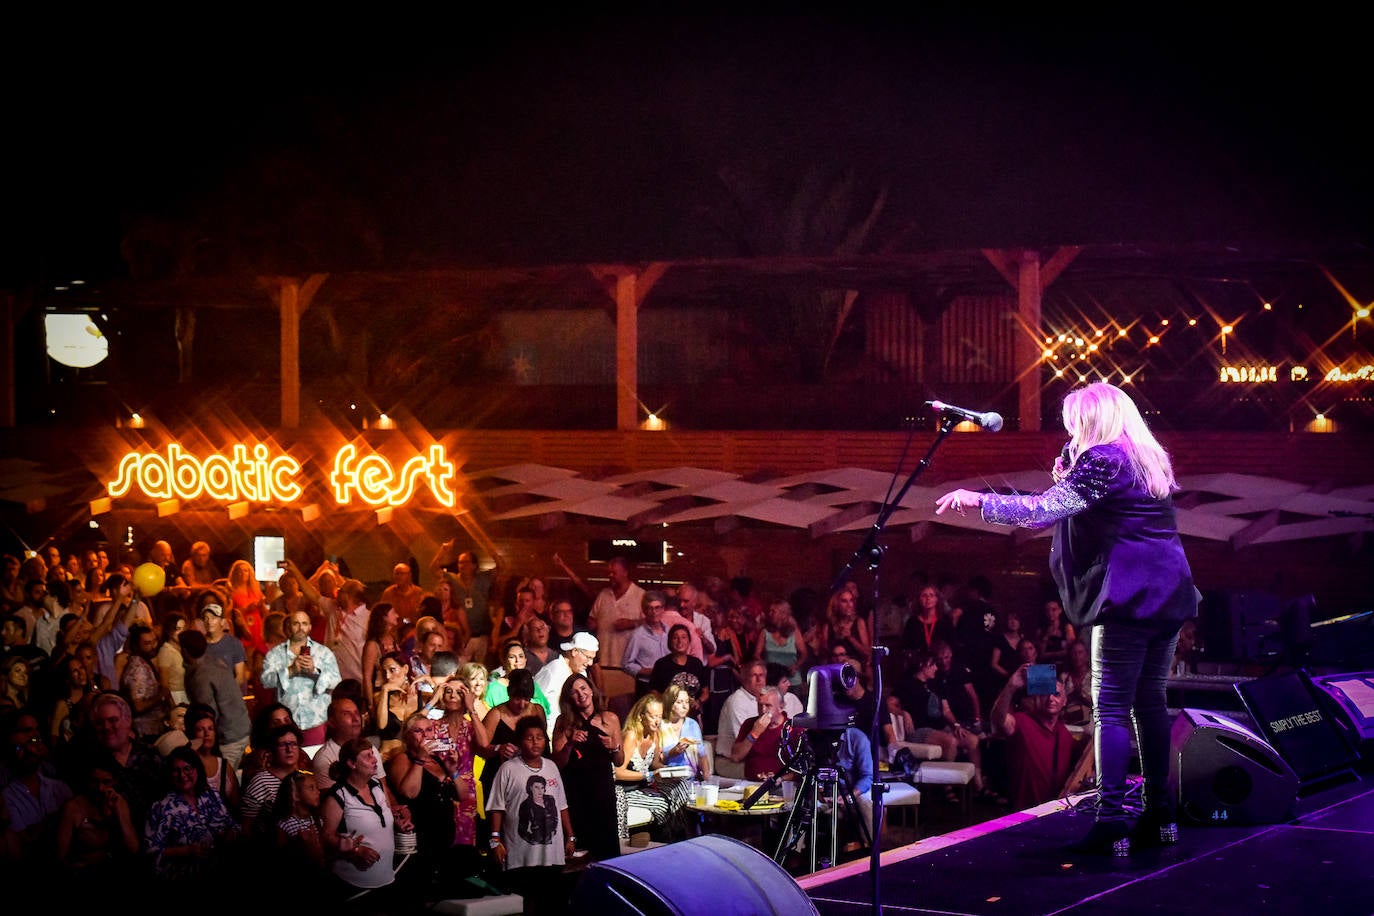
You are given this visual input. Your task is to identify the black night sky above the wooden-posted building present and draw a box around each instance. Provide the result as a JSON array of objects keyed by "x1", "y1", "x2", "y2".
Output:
[{"x1": 0, "y1": 5, "x2": 1374, "y2": 287}]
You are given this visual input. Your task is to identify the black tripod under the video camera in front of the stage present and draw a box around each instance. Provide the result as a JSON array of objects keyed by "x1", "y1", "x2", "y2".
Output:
[{"x1": 750, "y1": 731, "x2": 872, "y2": 872}]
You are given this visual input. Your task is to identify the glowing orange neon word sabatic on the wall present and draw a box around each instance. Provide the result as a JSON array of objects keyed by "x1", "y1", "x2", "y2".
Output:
[{"x1": 109, "y1": 442, "x2": 301, "y2": 503}]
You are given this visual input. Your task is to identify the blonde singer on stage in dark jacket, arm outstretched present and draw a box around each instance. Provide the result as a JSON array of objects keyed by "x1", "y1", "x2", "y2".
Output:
[{"x1": 936, "y1": 382, "x2": 1201, "y2": 856}]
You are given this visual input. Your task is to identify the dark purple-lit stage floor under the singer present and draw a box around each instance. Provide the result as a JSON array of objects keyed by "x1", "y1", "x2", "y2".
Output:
[{"x1": 800, "y1": 775, "x2": 1374, "y2": 916}]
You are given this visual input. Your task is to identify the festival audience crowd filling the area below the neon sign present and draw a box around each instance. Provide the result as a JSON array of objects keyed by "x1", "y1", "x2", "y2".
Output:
[{"x1": 0, "y1": 516, "x2": 1121, "y2": 912}]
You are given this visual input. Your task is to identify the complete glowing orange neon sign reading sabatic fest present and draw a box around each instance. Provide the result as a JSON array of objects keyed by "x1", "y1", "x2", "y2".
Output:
[{"x1": 107, "y1": 442, "x2": 458, "y2": 508}]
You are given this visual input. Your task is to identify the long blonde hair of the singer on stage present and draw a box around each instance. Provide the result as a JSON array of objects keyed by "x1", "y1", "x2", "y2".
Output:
[{"x1": 1063, "y1": 382, "x2": 1179, "y2": 499}]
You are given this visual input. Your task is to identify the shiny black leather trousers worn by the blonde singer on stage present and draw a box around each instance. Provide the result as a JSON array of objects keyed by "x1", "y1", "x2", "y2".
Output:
[{"x1": 1091, "y1": 621, "x2": 1182, "y2": 821}]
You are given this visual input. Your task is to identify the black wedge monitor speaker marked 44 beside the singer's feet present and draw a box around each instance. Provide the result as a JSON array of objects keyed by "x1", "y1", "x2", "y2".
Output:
[{"x1": 1169, "y1": 709, "x2": 1298, "y2": 824}]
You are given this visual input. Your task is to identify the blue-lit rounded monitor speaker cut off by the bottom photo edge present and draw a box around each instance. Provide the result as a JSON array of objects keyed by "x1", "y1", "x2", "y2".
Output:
[{"x1": 572, "y1": 834, "x2": 819, "y2": 916}]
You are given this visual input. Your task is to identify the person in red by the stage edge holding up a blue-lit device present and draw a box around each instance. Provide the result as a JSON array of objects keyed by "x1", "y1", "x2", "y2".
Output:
[{"x1": 991, "y1": 665, "x2": 1080, "y2": 809}]
